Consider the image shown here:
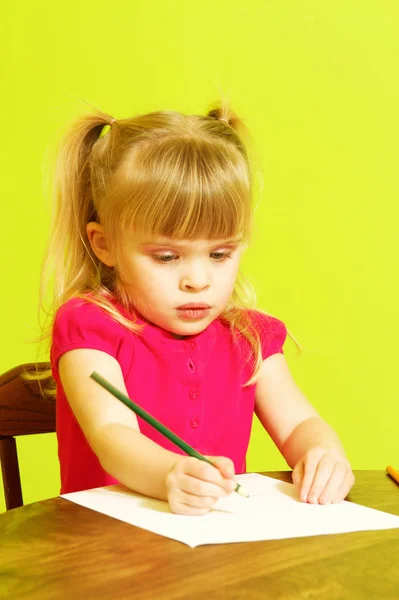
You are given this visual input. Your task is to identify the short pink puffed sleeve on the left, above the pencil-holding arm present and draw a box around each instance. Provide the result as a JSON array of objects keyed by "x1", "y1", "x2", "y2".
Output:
[{"x1": 50, "y1": 298, "x2": 125, "y2": 370}]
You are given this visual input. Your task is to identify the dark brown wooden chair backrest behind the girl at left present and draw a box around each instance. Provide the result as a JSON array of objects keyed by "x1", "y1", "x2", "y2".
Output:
[{"x1": 0, "y1": 363, "x2": 55, "y2": 510}]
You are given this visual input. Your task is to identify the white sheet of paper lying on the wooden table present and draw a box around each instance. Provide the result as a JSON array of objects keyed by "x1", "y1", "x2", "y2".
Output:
[{"x1": 62, "y1": 473, "x2": 399, "y2": 548}]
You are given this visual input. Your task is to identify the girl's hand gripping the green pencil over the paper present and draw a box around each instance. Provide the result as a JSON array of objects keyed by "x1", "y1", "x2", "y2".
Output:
[{"x1": 166, "y1": 456, "x2": 237, "y2": 515}]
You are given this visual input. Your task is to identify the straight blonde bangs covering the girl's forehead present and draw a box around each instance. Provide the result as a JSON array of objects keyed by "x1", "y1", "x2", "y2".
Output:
[{"x1": 108, "y1": 138, "x2": 252, "y2": 241}]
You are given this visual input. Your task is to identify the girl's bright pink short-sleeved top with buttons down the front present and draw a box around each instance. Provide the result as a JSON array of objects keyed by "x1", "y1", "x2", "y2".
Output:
[{"x1": 51, "y1": 298, "x2": 287, "y2": 494}]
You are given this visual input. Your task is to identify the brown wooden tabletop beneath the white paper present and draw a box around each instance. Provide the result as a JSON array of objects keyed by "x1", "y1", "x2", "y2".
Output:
[{"x1": 0, "y1": 471, "x2": 399, "y2": 600}]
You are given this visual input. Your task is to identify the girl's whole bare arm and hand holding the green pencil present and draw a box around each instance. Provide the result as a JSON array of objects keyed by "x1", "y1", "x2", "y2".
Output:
[{"x1": 59, "y1": 349, "x2": 236, "y2": 514}]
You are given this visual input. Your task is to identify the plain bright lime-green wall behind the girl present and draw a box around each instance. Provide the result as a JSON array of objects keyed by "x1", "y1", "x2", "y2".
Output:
[{"x1": 0, "y1": 0, "x2": 399, "y2": 511}]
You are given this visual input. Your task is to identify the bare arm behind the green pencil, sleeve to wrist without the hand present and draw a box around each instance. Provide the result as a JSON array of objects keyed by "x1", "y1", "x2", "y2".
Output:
[{"x1": 59, "y1": 349, "x2": 179, "y2": 499}]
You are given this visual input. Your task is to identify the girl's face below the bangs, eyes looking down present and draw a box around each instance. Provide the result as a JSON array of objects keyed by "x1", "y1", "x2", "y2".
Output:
[{"x1": 117, "y1": 235, "x2": 243, "y2": 336}]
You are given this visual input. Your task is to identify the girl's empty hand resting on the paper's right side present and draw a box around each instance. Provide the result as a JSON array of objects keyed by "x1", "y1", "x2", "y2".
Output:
[{"x1": 292, "y1": 446, "x2": 355, "y2": 504}]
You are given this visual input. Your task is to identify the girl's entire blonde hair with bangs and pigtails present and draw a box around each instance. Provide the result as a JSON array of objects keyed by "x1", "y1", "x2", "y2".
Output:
[{"x1": 37, "y1": 105, "x2": 298, "y2": 385}]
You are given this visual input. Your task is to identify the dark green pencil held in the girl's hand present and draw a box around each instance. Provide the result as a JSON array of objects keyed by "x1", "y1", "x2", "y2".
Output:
[{"x1": 90, "y1": 371, "x2": 248, "y2": 498}]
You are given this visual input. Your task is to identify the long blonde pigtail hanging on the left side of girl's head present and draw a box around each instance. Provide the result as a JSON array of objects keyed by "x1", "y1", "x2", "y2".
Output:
[{"x1": 41, "y1": 111, "x2": 115, "y2": 326}]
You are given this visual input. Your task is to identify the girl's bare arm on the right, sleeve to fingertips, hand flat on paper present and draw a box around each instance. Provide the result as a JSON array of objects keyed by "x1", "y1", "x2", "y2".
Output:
[{"x1": 255, "y1": 354, "x2": 354, "y2": 503}]
